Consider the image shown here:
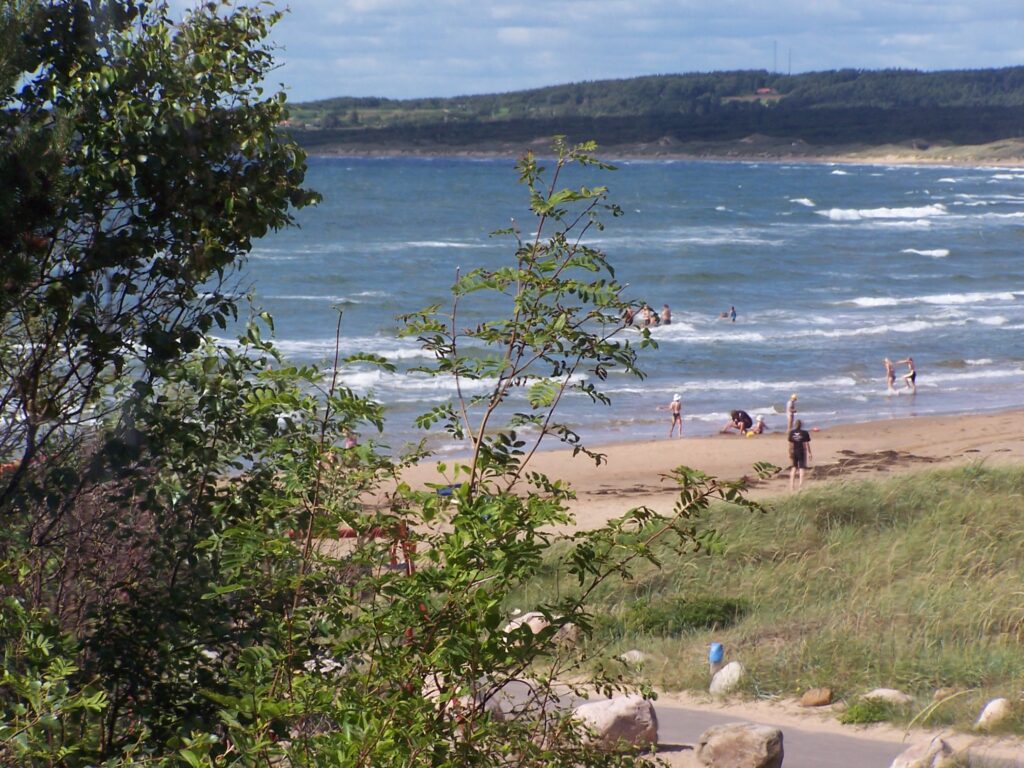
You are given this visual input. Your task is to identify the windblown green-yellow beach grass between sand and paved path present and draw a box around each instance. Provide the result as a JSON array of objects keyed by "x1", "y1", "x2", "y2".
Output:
[{"x1": 521, "y1": 465, "x2": 1024, "y2": 732}]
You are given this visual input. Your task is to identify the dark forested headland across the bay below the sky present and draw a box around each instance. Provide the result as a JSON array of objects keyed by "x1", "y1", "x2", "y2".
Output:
[{"x1": 289, "y1": 67, "x2": 1024, "y2": 159}]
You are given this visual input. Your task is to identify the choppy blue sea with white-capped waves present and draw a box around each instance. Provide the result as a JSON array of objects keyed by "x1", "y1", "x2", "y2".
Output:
[{"x1": 237, "y1": 158, "x2": 1024, "y2": 452}]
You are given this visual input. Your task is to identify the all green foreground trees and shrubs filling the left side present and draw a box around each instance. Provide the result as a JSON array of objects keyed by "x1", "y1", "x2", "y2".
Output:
[{"x1": 0, "y1": 0, "x2": 774, "y2": 768}]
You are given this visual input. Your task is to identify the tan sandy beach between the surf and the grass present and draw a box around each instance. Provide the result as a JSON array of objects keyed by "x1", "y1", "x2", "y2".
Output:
[{"x1": 406, "y1": 410, "x2": 1024, "y2": 528}]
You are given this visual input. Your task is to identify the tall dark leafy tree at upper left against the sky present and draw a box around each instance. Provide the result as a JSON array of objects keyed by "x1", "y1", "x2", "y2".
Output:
[{"x1": 0, "y1": 0, "x2": 312, "y2": 497}]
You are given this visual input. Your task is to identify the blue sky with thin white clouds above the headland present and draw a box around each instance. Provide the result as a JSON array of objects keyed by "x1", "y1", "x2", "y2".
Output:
[{"x1": 171, "y1": 0, "x2": 1024, "y2": 101}]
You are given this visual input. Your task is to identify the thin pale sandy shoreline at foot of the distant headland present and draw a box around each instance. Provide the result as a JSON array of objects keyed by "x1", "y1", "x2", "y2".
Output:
[{"x1": 296, "y1": 135, "x2": 1024, "y2": 168}]
